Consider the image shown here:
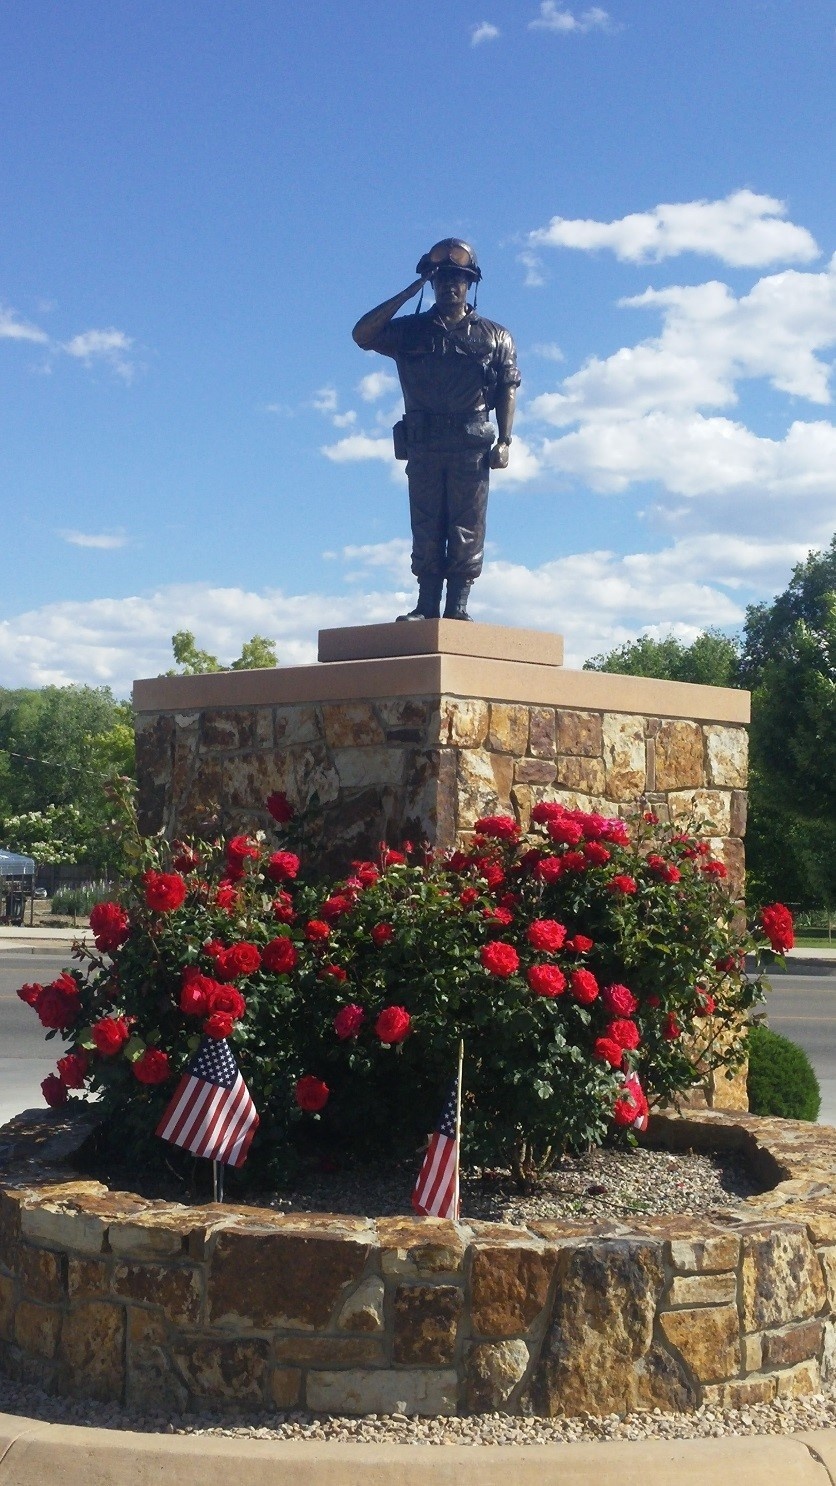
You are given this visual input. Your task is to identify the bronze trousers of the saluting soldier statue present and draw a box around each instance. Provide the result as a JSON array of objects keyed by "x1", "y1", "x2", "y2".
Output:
[{"x1": 407, "y1": 446, "x2": 489, "y2": 580}]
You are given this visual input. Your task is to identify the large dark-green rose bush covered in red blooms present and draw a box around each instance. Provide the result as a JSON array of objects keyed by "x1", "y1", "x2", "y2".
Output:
[{"x1": 21, "y1": 796, "x2": 788, "y2": 1175}]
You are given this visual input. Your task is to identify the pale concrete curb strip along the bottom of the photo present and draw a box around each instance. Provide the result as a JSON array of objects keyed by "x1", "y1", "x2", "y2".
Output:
[{"x1": 0, "y1": 1415, "x2": 836, "y2": 1486}]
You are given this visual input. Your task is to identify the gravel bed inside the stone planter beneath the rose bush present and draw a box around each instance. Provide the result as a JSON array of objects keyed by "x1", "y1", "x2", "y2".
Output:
[{"x1": 267, "y1": 1149, "x2": 762, "y2": 1226}]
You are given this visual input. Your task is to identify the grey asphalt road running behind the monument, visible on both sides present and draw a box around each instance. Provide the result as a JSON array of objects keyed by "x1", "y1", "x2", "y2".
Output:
[{"x1": 0, "y1": 948, "x2": 836, "y2": 1125}]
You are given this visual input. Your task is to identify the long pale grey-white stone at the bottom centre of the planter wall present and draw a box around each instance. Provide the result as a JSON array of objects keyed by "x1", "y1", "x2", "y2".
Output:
[{"x1": 306, "y1": 1367, "x2": 459, "y2": 1415}]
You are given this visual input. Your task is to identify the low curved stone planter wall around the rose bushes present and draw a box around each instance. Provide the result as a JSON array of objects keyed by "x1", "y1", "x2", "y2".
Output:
[{"x1": 0, "y1": 1112, "x2": 836, "y2": 1415}]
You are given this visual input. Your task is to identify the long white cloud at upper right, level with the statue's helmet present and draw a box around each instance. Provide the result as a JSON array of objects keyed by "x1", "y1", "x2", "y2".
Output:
[{"x1": 529, "y1": 190, "x2": 820, "y2": 267}]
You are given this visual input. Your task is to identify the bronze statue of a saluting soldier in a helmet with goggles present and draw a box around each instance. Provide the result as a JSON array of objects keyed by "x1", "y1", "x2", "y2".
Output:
[{"x1": 352, "y1": 238, "x2": 520, "y2": 620}]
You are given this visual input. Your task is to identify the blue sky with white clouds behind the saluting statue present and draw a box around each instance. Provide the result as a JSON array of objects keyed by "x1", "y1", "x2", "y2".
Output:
[{"x1": 0, "y1": 0, "x2": 836, "y2": 694}]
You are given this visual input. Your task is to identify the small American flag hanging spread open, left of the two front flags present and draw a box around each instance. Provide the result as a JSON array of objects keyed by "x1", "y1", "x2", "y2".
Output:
[{"x1": 157, "y1": 1037, "x2": 258, "y2": 1167}]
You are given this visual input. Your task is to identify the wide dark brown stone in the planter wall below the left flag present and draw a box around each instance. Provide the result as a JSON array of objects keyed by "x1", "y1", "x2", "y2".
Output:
[{"x1": 208, "y1": 1229, "x2": 370, "y2": 1331}]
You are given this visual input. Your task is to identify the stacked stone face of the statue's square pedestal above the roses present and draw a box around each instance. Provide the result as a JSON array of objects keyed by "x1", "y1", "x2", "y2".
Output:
[{"x1": 137, "y1": 695, "x2": 747, "y2": 893}]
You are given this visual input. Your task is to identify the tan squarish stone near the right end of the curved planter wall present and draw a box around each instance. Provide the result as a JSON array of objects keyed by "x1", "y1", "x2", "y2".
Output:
[{"x1": 742, "y1": 1227, "x2": 827, "y2": 1331}]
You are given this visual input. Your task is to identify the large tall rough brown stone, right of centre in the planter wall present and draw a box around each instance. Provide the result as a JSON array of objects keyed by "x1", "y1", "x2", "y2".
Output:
[{"x1": 529, "y1": 1239, "x2": 696, "y2": 1415}]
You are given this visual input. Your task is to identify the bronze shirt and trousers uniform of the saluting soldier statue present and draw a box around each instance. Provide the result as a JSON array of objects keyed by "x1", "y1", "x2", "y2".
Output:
[{"x1": 368, "y1": 306, "x2": 520, "y2": 583}]
